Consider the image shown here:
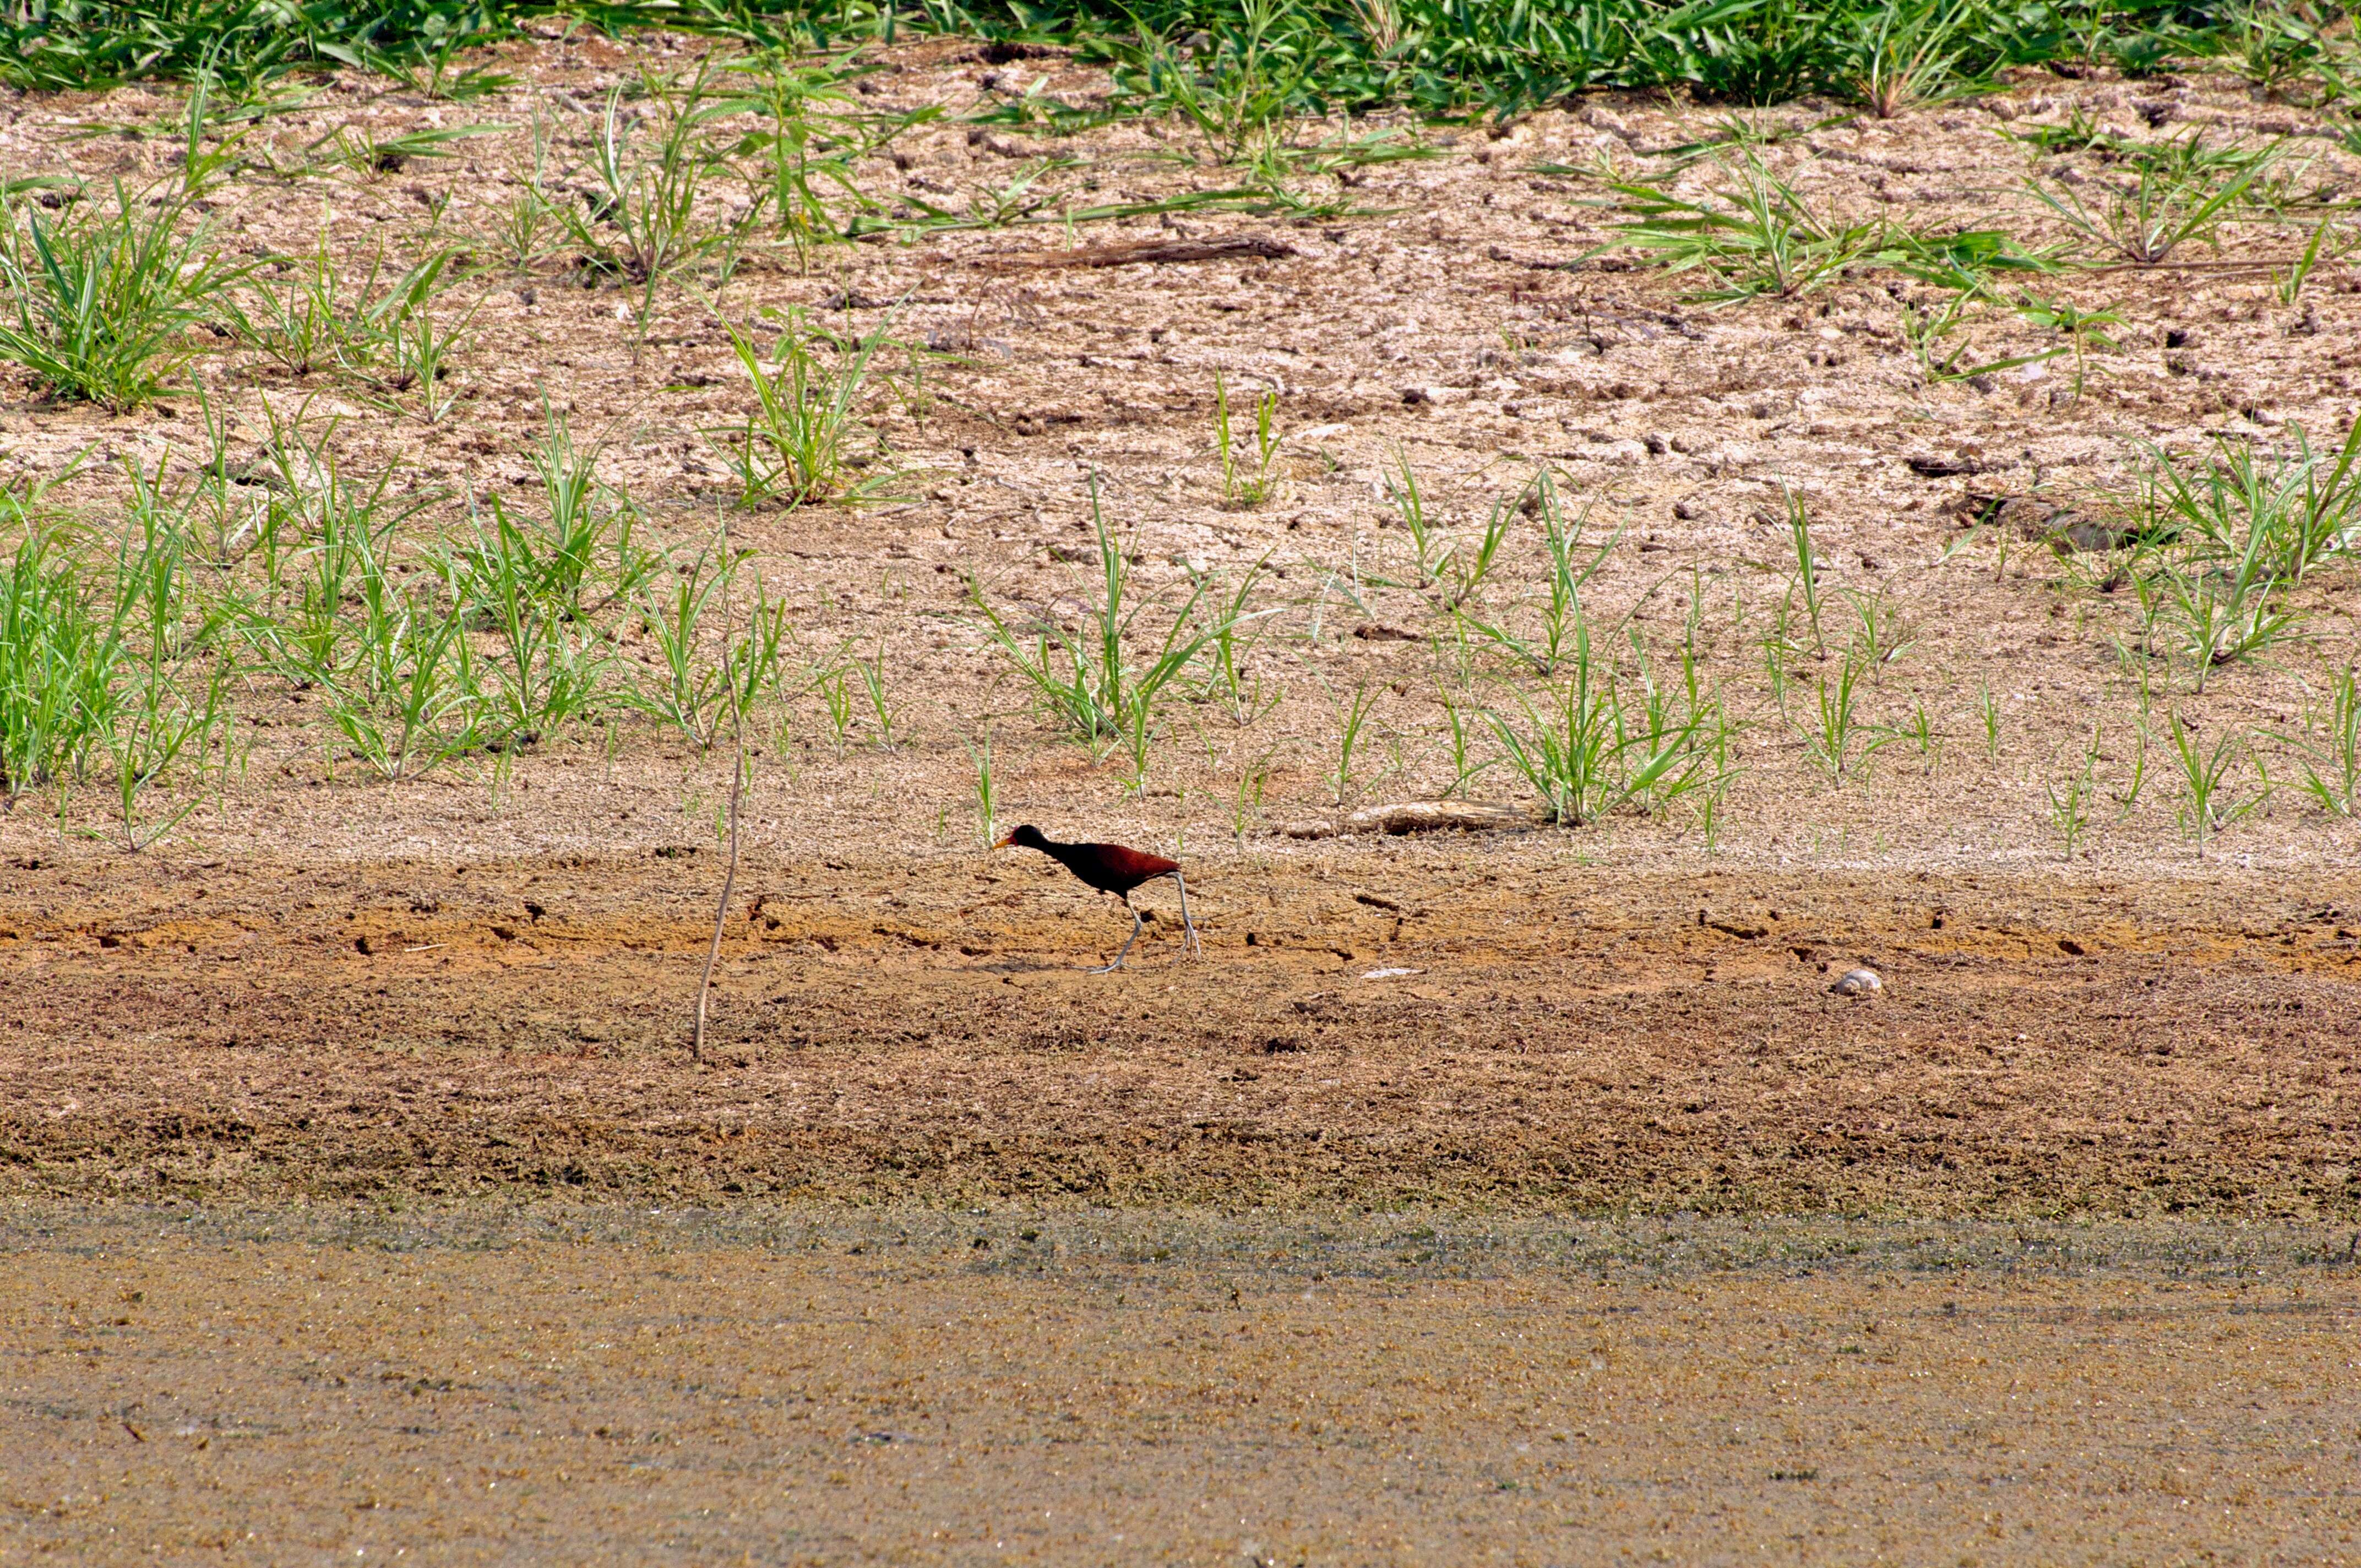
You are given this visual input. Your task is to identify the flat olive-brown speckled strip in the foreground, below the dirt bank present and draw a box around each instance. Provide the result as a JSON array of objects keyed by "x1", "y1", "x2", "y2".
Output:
[{"x1": 0, "y1": 1207, "x2": 2361, "y2": 1566}]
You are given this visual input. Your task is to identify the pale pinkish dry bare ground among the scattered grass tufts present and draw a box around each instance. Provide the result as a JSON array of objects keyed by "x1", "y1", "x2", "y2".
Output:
[{"x1": 0, "y1": 40, "x2": 2361, "y2": 869}]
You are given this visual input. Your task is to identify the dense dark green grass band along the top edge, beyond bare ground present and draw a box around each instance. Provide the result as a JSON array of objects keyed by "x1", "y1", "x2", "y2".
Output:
[{"x1": 0, "y1": 0, "x2": 2285, "y2": 124}]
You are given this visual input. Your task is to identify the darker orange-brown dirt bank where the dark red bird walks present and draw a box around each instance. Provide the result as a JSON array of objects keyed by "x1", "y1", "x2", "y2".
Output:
[{"x1": 0, "y1": 836, "x2": 2361, "y2": 1216}]
